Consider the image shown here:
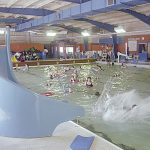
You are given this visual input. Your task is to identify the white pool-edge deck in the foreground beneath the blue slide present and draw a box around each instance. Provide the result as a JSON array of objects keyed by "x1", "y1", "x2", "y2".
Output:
[{"x1": 0, "y1": 121, "x2": 122, "y2": 150}]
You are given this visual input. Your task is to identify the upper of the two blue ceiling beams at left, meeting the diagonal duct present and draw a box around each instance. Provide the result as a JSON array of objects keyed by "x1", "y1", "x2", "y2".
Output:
[{"x1": 0, "y1": 7, "x2": 54, "y2": 16}]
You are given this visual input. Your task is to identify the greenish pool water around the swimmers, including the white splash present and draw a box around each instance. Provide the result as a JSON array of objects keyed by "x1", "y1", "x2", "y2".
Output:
[{"x1": 14, "y1": 64, "x2": 150, "y2": 150}]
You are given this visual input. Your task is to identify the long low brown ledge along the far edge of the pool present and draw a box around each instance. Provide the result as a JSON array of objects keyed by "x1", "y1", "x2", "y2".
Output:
[{"x1": 13, "y1": 58, "x2": 96, "y2": 67}]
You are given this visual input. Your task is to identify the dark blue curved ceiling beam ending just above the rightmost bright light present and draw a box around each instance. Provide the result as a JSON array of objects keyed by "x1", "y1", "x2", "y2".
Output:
[{"x1": 75, "y1": 18, "x2": 115, "y2": 32}]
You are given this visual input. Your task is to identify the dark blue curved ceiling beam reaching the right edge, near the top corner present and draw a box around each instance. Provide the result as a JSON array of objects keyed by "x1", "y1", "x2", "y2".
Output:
[{"x1": 119, "y1": 9, "x2": 150, "y2": 25}]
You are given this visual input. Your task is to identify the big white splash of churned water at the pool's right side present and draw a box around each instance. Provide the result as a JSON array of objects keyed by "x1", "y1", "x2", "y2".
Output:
[{"x1": 94, "y1": 90, "x2": 150, "y2": 123}]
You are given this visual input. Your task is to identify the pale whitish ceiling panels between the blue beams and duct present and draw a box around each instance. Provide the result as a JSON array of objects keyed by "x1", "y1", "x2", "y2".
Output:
[{"x1": 0, "y1": 0, "x2": 150, "y2": 44}]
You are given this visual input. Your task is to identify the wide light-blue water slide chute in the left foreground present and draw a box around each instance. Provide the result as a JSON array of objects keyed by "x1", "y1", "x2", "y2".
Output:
[{"x1": 0, "y1": 48, "x2": 84, "y2": 138}]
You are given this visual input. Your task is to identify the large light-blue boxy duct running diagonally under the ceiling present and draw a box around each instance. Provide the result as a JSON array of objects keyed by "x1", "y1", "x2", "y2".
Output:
[{"x1": 16, "y1": 0, "x2": 147, "y2": 31}]
